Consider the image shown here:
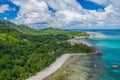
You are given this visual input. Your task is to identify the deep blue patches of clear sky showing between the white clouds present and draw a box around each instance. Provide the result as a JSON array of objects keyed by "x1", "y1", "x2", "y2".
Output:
[{"x1": 0, "y1": 0, "x2": 105, "y2": 20}]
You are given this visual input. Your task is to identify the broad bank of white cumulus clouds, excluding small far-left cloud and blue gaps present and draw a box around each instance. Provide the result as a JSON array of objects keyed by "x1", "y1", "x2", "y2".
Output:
[{"x1": 11, "y1": 0, "x2": 120, "y2": 29}]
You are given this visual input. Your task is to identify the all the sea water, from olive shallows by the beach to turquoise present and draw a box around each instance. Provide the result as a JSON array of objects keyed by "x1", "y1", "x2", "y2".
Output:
[{"x1": 44, "y1": 30, "x2": 120, "y2": 80}]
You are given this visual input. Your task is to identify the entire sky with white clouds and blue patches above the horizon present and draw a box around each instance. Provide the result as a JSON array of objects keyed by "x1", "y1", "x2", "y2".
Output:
[{"x1": 0, "y1": 0, "x2": 120, "y2": 28}]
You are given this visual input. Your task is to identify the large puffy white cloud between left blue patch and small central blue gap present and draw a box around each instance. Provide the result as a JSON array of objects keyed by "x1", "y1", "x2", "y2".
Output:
[{"x1": 13, "y1": 0, "x2": 50, "y2": 24}]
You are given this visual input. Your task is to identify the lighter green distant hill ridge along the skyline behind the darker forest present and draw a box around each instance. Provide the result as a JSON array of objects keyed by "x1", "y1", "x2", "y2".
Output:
[{"x1": 0, "y1": 20, "x2": 89, "y2": 38}]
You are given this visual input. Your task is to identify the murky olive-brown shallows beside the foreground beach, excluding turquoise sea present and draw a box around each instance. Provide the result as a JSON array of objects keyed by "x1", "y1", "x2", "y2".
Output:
[{"x1": 44, "y1": 55, "x2": 106, "y2": 80}]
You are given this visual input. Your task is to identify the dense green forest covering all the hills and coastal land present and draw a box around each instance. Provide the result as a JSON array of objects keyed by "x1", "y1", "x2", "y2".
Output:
[{"x1": 0, "y1": 20, "x2": 92, "y2": 80}]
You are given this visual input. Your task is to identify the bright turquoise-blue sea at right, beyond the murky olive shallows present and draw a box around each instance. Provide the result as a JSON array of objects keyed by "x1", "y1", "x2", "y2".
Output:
[{"x1": 91, "y1": 30, "x2": 120, "y2": 80}]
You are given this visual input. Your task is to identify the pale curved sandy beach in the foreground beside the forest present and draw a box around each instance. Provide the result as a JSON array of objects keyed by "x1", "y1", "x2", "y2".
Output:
[{"x1": 26, "y1": 53, "x2": 84, "y2": 80}]
